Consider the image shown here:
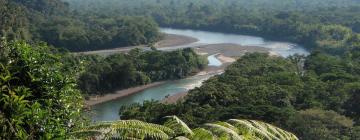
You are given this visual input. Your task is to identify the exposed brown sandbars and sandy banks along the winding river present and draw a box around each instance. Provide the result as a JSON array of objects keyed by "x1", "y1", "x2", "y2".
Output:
[{"x1": 81, "y1": 34, "x2": 270, "y2": 106}]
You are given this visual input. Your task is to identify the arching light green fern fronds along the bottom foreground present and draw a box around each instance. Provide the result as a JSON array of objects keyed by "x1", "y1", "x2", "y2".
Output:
[{"x1": 72, "y1": 116, "x2": 298, "y2": 140}]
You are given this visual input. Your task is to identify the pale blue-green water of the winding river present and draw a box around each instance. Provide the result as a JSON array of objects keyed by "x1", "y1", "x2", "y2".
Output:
[{"x1": 91, "y1": 28, "x2": 308, "y2": 121}]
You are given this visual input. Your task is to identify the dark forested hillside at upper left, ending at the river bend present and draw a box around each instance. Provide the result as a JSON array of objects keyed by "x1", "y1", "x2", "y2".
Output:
[{"x1": 0, "y1": 0, "x2": 161, "y2": 51}]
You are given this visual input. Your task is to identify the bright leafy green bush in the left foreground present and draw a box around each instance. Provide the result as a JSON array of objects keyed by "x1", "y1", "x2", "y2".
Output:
[{"x1": 0, "y1": 41, "x2": 82, "y2": 139}]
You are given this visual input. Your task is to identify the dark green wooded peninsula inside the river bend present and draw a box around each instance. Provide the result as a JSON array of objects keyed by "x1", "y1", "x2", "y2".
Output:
[{"x1": 74, "y1": 49, "x2": 207, "y2": 95}]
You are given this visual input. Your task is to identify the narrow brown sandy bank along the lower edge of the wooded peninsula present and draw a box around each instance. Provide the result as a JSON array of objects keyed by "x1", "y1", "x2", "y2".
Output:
[{"x1": 85, "y1": 81, "x2": 166, "y2": 106}]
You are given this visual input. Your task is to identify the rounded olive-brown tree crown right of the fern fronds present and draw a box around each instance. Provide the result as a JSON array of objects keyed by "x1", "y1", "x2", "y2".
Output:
[{"x1": 289, "y1": 109, "x2": 353, "y2": 140}]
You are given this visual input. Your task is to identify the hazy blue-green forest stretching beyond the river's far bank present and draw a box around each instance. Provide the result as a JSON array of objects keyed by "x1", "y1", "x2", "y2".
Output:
[{"x1": 66, "y1": 0, "x2": 360, "y2": 53}]
